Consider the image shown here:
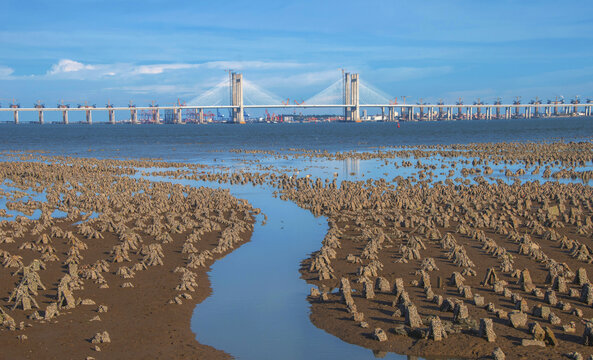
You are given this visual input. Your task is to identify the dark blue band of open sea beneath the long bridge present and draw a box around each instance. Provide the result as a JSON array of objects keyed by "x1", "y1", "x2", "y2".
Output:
[{"x1": 0, "y1": 117, "x2": 593, "y2": 161}]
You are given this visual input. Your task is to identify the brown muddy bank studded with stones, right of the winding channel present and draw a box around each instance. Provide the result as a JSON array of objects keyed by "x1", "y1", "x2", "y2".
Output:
[{"x1": 282, "y1": 174, "x2": 593, "y2": 359}]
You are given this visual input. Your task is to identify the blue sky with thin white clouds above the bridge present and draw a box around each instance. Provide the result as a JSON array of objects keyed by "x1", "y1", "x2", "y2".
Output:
[{"x1": 0, "y1": 0, "x2": 593, "y2": 112}]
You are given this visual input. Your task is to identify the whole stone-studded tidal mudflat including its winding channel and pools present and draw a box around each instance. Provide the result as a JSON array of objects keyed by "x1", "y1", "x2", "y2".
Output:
[{"x1": 0, "y1": 121, "x2": 593, "y2": 359}]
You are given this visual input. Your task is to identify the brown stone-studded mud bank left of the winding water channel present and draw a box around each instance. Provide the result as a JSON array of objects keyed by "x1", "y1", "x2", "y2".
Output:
[{"x1": 0, "y1": 159, "x2": 258, "y2": 359}]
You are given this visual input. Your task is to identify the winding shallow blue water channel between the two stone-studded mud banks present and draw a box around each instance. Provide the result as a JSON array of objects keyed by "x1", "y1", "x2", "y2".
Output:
[{"x1": 147, "y1": 176, "x2": 416, "y2": 359}]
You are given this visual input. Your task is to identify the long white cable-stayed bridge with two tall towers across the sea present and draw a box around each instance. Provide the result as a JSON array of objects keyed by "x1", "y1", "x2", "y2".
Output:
[{"x1": 0, "y1": 72, "x2": 593, "y2": 124}]
